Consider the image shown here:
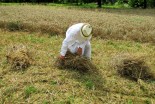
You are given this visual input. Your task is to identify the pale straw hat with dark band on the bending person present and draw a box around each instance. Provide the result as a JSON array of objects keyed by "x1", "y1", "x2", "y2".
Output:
[{"x1": 81, "y1": 24, "x2": 93, "y2": 38}]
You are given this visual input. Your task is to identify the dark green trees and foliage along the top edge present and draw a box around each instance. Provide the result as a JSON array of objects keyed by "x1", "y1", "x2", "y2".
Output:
[{"x1": 0, "y1": 0, "x2": 155, "y2": 8}]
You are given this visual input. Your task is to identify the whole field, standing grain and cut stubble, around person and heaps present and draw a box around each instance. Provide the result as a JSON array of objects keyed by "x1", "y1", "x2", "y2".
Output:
[{"x1": 0, "y1": 5, "x2": 155, "y2": 104}]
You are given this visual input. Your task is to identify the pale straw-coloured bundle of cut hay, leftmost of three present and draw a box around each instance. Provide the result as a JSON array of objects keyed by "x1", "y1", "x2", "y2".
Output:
[{"x1": 6, "y1": 44, "x2": 31, "y2": 70}]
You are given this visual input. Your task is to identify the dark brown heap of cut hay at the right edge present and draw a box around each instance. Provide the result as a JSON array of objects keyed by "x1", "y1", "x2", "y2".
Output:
[{"x1": 112, "y1": 54, "x2": 155, "y2": 81}]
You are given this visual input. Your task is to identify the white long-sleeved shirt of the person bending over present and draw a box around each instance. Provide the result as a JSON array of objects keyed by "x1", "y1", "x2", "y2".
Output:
[{"x1": 60, "y1": 23, "x2": 91, "y2": 56}]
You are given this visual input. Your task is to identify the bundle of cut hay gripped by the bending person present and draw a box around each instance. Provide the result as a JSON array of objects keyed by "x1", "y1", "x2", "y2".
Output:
[{"x1": 55, "y1": 51, "x2": 96, "y2": 72}]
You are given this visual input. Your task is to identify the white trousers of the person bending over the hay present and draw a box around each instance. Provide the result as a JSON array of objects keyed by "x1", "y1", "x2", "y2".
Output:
[{"x1": 68, "y1": 42, "x2": 91, "y2": 59}]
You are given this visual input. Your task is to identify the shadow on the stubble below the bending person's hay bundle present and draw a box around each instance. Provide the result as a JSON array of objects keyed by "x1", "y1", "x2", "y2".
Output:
[{"x1": 63, "y1": 65, "x2": 105, "y2": 94}]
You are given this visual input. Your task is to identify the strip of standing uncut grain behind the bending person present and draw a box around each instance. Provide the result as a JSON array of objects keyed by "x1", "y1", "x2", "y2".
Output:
[{"x1": 0, "y1": 5, "x2": 155, "y2": 42}]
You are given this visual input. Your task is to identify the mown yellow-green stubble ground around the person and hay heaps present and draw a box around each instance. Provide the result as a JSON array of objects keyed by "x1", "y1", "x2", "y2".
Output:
[{"x1": 0, "y1": 30, "x2": 155, "y2": 104}]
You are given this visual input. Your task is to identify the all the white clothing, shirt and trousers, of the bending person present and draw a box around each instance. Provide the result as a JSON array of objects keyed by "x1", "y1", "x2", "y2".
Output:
[{"x1": 60, "y1": 23, "x2": 91, "y2": 58}]
